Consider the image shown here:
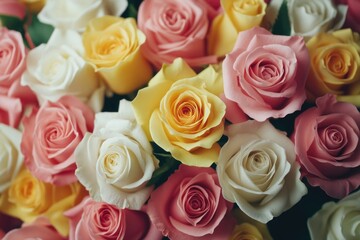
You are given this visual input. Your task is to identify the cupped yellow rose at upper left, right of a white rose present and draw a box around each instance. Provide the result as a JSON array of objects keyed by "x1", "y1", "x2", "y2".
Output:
[{"x1": 83, "y1": 16, "x2": 152, "y2": 94}]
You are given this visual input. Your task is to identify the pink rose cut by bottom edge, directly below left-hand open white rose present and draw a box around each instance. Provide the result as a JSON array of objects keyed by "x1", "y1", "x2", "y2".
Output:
[{"x1": 64, "y1": 197, "x2": 161, "y2": 240}]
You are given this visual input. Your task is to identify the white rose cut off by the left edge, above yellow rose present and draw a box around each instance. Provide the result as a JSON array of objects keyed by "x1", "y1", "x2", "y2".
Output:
[{"x1": 0, "y1": 124, "x2": 24, "y2": 195}]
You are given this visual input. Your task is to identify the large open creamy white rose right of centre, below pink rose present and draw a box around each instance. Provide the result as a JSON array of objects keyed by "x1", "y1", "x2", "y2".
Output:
[{"x1": 217, "y1": 121, "x2": 307, "y2": 223}]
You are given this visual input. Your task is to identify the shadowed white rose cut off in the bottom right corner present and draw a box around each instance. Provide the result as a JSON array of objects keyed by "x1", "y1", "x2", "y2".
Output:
[{"x1": 308, "y1": 189, "x2": 360, "y2": 240}]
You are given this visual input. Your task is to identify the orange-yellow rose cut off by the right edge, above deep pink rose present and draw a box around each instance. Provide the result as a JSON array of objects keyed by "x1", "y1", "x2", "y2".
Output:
[{"x1": 306, "y1": 29, "x2": 360, "y2": 106}]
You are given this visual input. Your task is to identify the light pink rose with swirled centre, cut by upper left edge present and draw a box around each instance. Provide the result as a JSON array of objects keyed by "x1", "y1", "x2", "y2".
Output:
[{"x1": 0, "y1": 27, "x2": 27, "y2": 88}]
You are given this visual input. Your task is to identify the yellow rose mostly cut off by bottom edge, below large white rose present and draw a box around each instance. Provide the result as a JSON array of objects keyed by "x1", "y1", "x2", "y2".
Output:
[{"x1": 229, "y1": 208, "x2": 272, "y2": 240}]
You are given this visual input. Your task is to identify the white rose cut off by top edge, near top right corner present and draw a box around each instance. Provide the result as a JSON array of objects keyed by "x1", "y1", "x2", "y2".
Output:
[{"x1": 287, "y1": 0, "x2": 347, "y2": 38}]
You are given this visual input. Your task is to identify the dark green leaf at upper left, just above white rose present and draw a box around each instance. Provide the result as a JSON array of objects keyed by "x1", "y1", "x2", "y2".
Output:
[{"x1": 28, "y1": 15, "x2": 54, "y2": 46}]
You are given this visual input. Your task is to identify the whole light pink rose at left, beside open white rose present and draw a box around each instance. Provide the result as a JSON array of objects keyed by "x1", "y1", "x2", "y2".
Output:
[{"x1": 21, "y1": 96, "x2": 94, "y2": 185}]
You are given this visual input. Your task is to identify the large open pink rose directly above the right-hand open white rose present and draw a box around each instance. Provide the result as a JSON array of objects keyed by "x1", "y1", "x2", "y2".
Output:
[{"x1": 223, "y1": 27, "x2": 310, "y2": 121}]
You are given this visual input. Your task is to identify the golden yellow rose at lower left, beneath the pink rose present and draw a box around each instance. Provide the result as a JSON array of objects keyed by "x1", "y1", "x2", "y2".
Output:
[{"x1": 0, "y1": 169, "x2": 87, "y2": 236}]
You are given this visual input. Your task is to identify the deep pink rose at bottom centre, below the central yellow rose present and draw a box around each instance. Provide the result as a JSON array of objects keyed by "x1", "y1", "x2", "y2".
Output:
[{"x1": 147, "y1": 164, "x2": 235, "y2": 240}]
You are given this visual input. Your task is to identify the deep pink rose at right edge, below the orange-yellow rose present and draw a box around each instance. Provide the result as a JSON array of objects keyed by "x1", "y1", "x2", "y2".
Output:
[{"x1": 292, "y1": 94, "x2": 360, "y2": 198}]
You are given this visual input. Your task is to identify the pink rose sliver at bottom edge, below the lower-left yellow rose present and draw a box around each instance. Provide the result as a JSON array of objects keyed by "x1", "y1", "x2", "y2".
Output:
[{"x1": 2, "y1": 218, "x2": 66, "y2": 240}]
